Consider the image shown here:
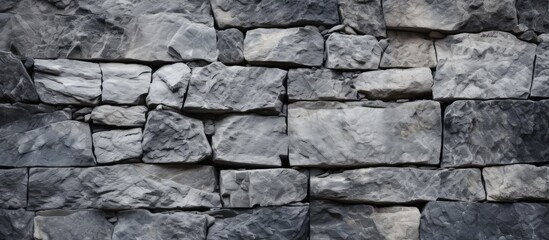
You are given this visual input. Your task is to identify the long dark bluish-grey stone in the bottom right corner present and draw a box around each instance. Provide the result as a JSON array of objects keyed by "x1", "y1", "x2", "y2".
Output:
[{"x1": 420, "y1": 202, "x2": 549, "y2": 240}]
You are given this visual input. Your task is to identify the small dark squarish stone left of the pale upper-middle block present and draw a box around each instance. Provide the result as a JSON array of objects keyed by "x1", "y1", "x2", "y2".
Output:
[{"x1": 217, "y1": 28, "x2": 244, "y2": 64}]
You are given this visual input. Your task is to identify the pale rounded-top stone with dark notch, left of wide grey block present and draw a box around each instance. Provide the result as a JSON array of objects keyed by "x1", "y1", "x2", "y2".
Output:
[{"x1": 147, "y1": 63, "x2": 191, "y2": 109}]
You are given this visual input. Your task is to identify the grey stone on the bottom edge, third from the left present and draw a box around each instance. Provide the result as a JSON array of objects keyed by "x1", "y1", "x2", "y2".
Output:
[{"x1": 112, "y1": 210, "x2": 207, "y2": 240}]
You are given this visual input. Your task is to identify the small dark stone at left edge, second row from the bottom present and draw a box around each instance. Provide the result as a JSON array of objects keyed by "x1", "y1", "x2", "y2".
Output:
[{"x1": 0, "y1": 168, "x2": 28, "y2": 208}]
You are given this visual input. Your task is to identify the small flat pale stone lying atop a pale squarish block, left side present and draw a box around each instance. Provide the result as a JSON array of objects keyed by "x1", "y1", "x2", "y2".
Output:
[{"x1": 91, "y1": 105, "x2": 147, "y2": 127}]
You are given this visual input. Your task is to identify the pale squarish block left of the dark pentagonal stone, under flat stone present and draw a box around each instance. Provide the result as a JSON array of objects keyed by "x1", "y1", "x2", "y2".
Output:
[{"x1": 92, "y1": 128, "x2": 143, "y2": 163}]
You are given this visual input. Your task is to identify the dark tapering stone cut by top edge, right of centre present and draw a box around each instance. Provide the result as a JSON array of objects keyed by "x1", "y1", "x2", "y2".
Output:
[{"x1": 338, "y1": 0, "x2": 385, "y2": 37}]
